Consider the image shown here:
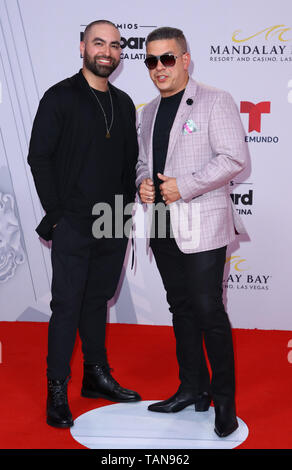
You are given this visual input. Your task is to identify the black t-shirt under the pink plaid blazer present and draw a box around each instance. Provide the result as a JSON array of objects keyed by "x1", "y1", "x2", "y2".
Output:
[{"x1": 153, "y1": 90, "x2": 184, "y2": 203}]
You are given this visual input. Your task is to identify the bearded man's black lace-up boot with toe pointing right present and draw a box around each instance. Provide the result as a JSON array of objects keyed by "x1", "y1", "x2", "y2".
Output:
[{"x1": 81, "y1": 363, "x2": 141, "y2": 402}]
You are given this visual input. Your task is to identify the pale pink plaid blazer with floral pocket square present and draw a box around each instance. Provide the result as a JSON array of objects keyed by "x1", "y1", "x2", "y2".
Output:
[{"x1": 136, "y1": 78, "x2": 249, "y2": 253}]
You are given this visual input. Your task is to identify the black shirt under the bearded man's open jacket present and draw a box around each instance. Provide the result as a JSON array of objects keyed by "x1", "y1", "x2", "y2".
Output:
[{"x1": 66, "y1": 88, "x2": 125, "y2": 231}]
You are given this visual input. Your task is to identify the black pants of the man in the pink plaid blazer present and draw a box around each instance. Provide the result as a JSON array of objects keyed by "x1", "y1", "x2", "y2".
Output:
[{"x1": 150, "y1": 238, "x2": 235, "y2": 404}]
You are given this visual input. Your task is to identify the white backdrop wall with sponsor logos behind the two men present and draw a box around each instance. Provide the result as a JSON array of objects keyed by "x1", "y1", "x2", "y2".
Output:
[{"x1": 0, "y1": 0, "x2": 292, "y2": 330}]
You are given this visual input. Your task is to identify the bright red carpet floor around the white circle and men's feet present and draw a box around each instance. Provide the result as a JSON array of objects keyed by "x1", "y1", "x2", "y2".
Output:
[{"x1": 0, "y1": 322, "x2": 292, "y2": 449}]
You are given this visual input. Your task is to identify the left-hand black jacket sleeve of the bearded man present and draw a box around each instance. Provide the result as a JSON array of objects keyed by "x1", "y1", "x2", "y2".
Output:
[{"x1": 27, "y1": 89, "x2": 63, "y2": 239}]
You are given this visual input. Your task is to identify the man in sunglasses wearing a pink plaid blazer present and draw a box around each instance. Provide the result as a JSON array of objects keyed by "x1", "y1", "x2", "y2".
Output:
[{"x1": 136, "y1": 27, "x2": 248, "y2": 437}]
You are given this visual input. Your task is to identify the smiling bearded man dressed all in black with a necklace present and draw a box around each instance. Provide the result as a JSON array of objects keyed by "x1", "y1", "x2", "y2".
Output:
[{"x1": 28, "y1": 20, "x2": 141, "y2": 427}]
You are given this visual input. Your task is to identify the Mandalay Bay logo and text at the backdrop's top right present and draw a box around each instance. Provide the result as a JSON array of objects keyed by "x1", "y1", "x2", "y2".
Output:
[{"x1": 210, "y1": 24, "x2": 292, "y2": 64}]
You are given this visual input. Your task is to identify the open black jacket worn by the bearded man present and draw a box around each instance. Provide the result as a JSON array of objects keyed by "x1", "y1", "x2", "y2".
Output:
[{"x1": 27, "y1": 70, "x2": 138, "y2": 240}]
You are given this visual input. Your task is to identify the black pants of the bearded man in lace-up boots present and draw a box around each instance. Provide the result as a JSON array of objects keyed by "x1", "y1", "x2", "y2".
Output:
[{"x1": 47, "y1": 218, "x2": 128, "y2": 380}]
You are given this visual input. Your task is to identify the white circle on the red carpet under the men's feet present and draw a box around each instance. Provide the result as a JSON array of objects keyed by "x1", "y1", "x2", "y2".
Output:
[{"x1": 71, "y1": 401, "x2": 248, "y2": 449}]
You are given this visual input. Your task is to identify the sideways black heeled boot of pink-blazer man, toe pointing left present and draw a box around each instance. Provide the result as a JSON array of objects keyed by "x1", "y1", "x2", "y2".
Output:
[{"x1": 148, "y1": 390, "x2": 211, "y2": 413}]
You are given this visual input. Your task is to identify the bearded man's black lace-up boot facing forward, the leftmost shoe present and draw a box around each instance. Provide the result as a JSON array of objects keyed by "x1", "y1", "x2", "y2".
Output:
[{"x1": 47, "y1": 379, "x2": 74, "y2": 428}]
